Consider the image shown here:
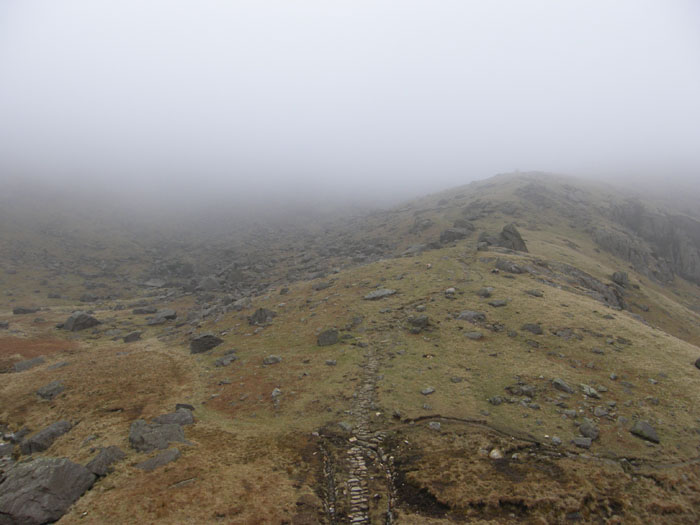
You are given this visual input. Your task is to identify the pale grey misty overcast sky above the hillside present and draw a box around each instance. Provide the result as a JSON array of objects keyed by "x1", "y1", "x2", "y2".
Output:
[{"x1": 0, "y1": 0, "x2": 700, "y2": 203}]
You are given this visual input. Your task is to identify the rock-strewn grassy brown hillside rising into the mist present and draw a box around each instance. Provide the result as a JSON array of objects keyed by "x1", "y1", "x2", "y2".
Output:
[{"x1": 0, "y1": 173, "x2": 700, "y2": 525}]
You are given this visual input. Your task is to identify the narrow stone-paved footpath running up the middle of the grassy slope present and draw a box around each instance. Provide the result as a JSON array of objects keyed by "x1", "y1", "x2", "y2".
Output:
[{"x1": 324, "y1": 346, "x2": 395, "y2": 524}]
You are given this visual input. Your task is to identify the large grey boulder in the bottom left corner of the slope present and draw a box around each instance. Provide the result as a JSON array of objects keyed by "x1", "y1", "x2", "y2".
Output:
[{"x1": 0, "y1": 458, "x2": 95, "y2": 525}]
